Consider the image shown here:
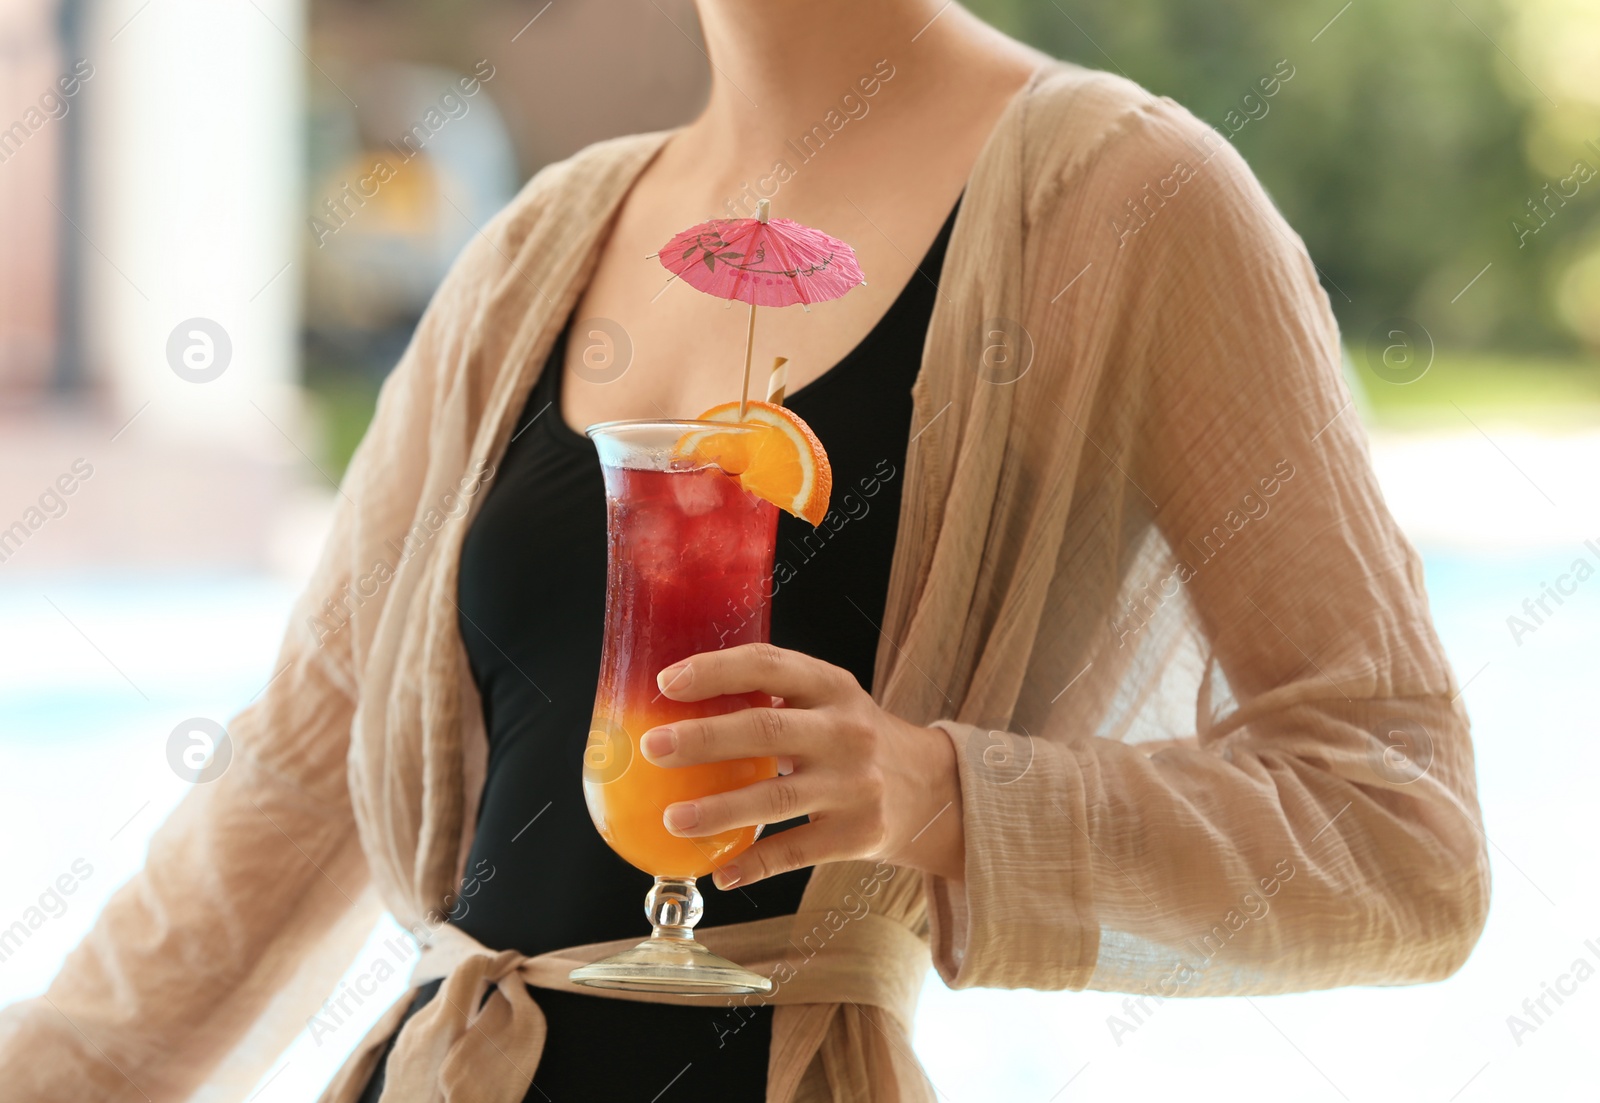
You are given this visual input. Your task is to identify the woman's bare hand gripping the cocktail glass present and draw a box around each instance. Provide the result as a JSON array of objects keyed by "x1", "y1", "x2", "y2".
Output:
[{"x1": 640, "y1": 644, "x2": 965, "y2": 888}]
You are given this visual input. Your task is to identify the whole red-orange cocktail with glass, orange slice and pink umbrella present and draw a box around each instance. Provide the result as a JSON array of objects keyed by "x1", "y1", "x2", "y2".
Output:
[{"x1": 571, "y1": 199, "x2": 862, "y2": 993}]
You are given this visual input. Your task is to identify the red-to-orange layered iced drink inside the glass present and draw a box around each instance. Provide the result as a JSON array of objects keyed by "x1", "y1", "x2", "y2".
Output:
[{"x1": 584, "y1": 467, "x2": 778, "y2": 877}]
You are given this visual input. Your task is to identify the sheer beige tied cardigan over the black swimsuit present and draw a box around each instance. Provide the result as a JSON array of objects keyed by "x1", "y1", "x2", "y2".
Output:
[{"x1": 0, "y1": 64, "x2": 1488, "y2": 1103}]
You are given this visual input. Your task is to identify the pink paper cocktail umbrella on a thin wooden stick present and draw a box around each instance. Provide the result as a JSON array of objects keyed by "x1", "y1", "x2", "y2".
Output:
[{"x1": 658, "y1": 199, "x2": 866, "y2": 418}]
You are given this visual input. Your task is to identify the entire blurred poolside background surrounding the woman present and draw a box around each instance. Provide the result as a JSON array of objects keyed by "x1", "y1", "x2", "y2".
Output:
[{"x1": 0, "y1": 0, "x2": 1600, "y2": 1103}]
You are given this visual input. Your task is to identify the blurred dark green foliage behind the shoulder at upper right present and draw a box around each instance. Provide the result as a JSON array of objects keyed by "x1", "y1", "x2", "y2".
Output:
[{"x1": 971, "y1": 0, "x2": 1600, "y2": 349}]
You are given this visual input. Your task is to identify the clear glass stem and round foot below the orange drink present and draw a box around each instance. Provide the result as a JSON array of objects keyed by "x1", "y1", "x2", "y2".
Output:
[{"x1": 568, "y1": 877, "x2": 773, "y2": 996}]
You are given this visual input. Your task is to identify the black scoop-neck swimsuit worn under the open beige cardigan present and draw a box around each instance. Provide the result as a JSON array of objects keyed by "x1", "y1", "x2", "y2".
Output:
[{"x1": 362, "y1": 203, "x2": 958, "y2": 1103}]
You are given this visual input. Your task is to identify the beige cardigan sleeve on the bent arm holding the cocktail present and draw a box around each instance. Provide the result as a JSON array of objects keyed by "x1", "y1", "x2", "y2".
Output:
[{"x1": 930, "y1": 101, "x2": 1488, "y2": 999}]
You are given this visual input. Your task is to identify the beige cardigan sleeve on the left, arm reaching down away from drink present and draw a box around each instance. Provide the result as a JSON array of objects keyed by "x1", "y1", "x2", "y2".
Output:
[{"x1": 0, "y1": 220, "x2": 504, "y2": 1103}]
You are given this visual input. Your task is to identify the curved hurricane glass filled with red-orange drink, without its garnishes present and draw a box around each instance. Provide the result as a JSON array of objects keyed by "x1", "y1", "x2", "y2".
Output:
[{"x1": 571, "y1": 421, "x2": 778, "y2": 994}]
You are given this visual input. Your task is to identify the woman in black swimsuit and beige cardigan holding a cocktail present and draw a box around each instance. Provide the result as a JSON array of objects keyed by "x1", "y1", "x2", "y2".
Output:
[{"x1": 0, "y1": 0, "x2": 1488, "y2": 1101}]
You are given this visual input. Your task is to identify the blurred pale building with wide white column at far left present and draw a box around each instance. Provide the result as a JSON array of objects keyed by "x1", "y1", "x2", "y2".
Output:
[{"x1": 0, "y1": 0, "x2": 306, "y2": 572}]
